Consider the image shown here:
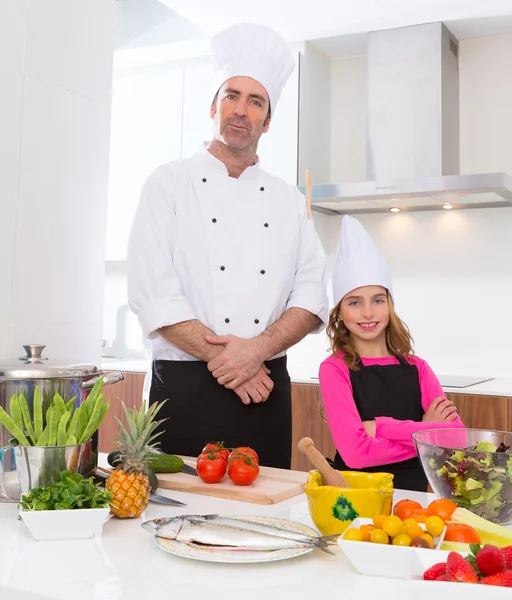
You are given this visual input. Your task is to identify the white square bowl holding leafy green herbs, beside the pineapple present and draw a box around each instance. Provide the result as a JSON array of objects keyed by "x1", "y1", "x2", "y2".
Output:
[{"x1": 20, "y1": 507, "x2": 110, "y2": 540}]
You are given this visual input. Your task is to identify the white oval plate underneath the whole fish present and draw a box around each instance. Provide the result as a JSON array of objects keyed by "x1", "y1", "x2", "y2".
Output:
[{"x1": 155, "y1": 516, "x2": 318, "y2": 563}]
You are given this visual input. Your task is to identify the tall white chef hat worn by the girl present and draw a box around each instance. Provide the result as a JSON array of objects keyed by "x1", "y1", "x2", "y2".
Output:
[{"x1": 332, "y1": 215, "x2": 393, "y2": 306}]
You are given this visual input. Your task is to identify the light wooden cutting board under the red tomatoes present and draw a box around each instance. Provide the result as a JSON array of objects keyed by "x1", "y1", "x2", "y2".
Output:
[{"x1": 157, "y1": 456, "x2": 308, "y2": 504}]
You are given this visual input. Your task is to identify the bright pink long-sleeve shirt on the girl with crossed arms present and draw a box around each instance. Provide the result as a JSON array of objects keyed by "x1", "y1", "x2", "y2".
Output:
[{"x1": 319, "y1": 354, "x2": 464, "y2": 469}]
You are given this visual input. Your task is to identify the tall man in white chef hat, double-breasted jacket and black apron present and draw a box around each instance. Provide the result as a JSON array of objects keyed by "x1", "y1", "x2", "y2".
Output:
[{"x1": 128, "y1": 24, "x2": 328, "y2": 468}]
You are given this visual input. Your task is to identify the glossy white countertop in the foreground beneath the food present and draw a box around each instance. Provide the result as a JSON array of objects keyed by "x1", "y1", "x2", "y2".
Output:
[{"x1": 0, "y1": 482, "x2": 484, "y2": 600}]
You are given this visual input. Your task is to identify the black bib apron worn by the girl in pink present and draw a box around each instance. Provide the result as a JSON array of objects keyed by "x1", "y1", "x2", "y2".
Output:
[{"x1": 333, "y1": 357, "x2": 428, "y2": 492}]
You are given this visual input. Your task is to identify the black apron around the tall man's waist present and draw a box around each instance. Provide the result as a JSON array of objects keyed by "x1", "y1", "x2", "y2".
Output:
[{"x1": 149, "y1": 356, "x2": 292, "y2": 469}]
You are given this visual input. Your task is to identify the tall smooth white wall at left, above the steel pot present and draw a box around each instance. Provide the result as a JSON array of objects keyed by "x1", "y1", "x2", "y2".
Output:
[{"x1": 0, "y1": 0, "x2": 117, "y2": 363}]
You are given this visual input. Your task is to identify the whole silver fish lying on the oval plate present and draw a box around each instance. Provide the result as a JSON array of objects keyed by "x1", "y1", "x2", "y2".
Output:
[{"x1": 142, "y1": 515, "x2": 338, "y2": 554}]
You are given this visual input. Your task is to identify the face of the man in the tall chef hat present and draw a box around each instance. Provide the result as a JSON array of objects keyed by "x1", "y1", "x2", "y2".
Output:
[{"x1": 210, "y1": 77, "x2": 270, "y2": 150}]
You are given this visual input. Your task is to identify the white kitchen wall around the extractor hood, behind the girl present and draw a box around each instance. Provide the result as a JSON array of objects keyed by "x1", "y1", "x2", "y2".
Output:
[{"x1": 320, "y1": 35, "x2": 512, "y2": 376}]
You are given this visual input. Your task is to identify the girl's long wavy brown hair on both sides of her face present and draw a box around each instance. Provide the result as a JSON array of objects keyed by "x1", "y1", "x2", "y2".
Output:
[{"x1": 326, "y1": 292, "x2": 414, "y2": 371}]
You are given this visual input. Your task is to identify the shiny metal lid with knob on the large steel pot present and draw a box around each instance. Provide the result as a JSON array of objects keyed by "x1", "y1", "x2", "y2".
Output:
[{"x1": 0, "y1": 344, "x2": 103, "y2": 381}]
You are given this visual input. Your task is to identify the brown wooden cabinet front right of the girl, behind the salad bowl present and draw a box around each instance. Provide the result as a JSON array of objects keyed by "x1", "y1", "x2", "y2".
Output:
[{"x1": 446, "y1": 394, "x2": 512, "y2": 431}]
